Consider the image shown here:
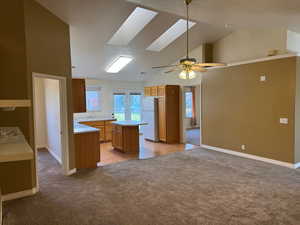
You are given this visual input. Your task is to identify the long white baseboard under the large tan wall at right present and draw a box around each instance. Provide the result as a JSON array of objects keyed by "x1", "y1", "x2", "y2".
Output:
[{"x1": 201, "y1": 144, "x2": 300, "y2": 169}]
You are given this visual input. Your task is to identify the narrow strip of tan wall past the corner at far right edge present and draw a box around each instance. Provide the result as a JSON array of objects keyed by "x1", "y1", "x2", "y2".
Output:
[{"x1": 295, "y1": 57, "x2": 300, "y2": 163}]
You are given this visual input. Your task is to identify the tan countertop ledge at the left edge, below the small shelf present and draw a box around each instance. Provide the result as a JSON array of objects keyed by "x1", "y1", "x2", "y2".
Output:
[{"x1": 0, "y1": 127, "x2": 34, "y2": 163}]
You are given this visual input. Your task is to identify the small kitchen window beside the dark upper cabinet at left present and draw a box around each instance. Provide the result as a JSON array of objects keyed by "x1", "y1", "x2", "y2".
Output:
[{"x1": 86, "y1": 86, "x2": 101, "y2": 112}]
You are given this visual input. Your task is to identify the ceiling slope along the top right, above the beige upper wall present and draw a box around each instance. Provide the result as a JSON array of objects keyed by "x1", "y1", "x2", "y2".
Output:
[{"x1": 128, "y1": 0, "x2": 300, "y2": 31}]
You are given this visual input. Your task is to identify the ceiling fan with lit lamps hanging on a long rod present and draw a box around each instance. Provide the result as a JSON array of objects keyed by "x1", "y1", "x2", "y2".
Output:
[{"x1": 152, "y1": 0, "x2": 226, "y2": 80}]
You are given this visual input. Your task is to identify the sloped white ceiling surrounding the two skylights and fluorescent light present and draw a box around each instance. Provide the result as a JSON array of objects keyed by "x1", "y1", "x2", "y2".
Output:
[{"x1": 37, "y1": 0, "x2": 232, "y2": 81}]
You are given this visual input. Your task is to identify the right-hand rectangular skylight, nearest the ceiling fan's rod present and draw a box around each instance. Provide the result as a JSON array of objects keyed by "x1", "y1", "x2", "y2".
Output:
[{"x1": 147, "y1": 19, "x2": 196, "y2": 52}]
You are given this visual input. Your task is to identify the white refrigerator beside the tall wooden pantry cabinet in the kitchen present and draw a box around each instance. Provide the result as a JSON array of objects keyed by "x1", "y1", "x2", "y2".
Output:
[{"x1": 141, "y1": 97, "x2": 159, "y2": 142}]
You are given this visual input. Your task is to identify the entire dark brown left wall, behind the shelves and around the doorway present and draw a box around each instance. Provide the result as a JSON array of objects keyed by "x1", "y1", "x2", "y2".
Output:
[{"x1": 0, "y1": 0, "x2": 74, "y2": 194}]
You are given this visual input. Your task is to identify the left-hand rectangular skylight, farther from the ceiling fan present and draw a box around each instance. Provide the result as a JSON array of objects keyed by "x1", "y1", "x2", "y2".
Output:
[{"x1": 108, "y1": 7, "x2": 158, "y2": 45}]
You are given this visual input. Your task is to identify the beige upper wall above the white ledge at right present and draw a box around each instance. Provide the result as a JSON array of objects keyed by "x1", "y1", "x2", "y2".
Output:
[{"x1": 213, "y1": 29, "x2": 287, "y2": 63}]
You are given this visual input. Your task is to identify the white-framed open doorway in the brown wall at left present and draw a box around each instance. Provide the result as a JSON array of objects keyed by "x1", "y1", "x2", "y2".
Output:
[{"x1": 33, "y1": 74, "x2": 69, "y2": 182}]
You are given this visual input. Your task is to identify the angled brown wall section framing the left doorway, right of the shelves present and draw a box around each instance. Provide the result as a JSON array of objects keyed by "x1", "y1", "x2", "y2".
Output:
[{"x1": 24, "y1": 0, "x2": 75, "y2": 169}]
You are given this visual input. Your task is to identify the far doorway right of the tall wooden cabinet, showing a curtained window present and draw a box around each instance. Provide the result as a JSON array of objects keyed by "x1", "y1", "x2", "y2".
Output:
[{"x1": 183, "y1": 85, "x2": 201, "y2": 146}]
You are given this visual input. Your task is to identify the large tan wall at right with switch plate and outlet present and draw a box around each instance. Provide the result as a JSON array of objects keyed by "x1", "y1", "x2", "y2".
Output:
[{"x1": 201, "y1": 57, "x2": 296, "y2": 163}]
